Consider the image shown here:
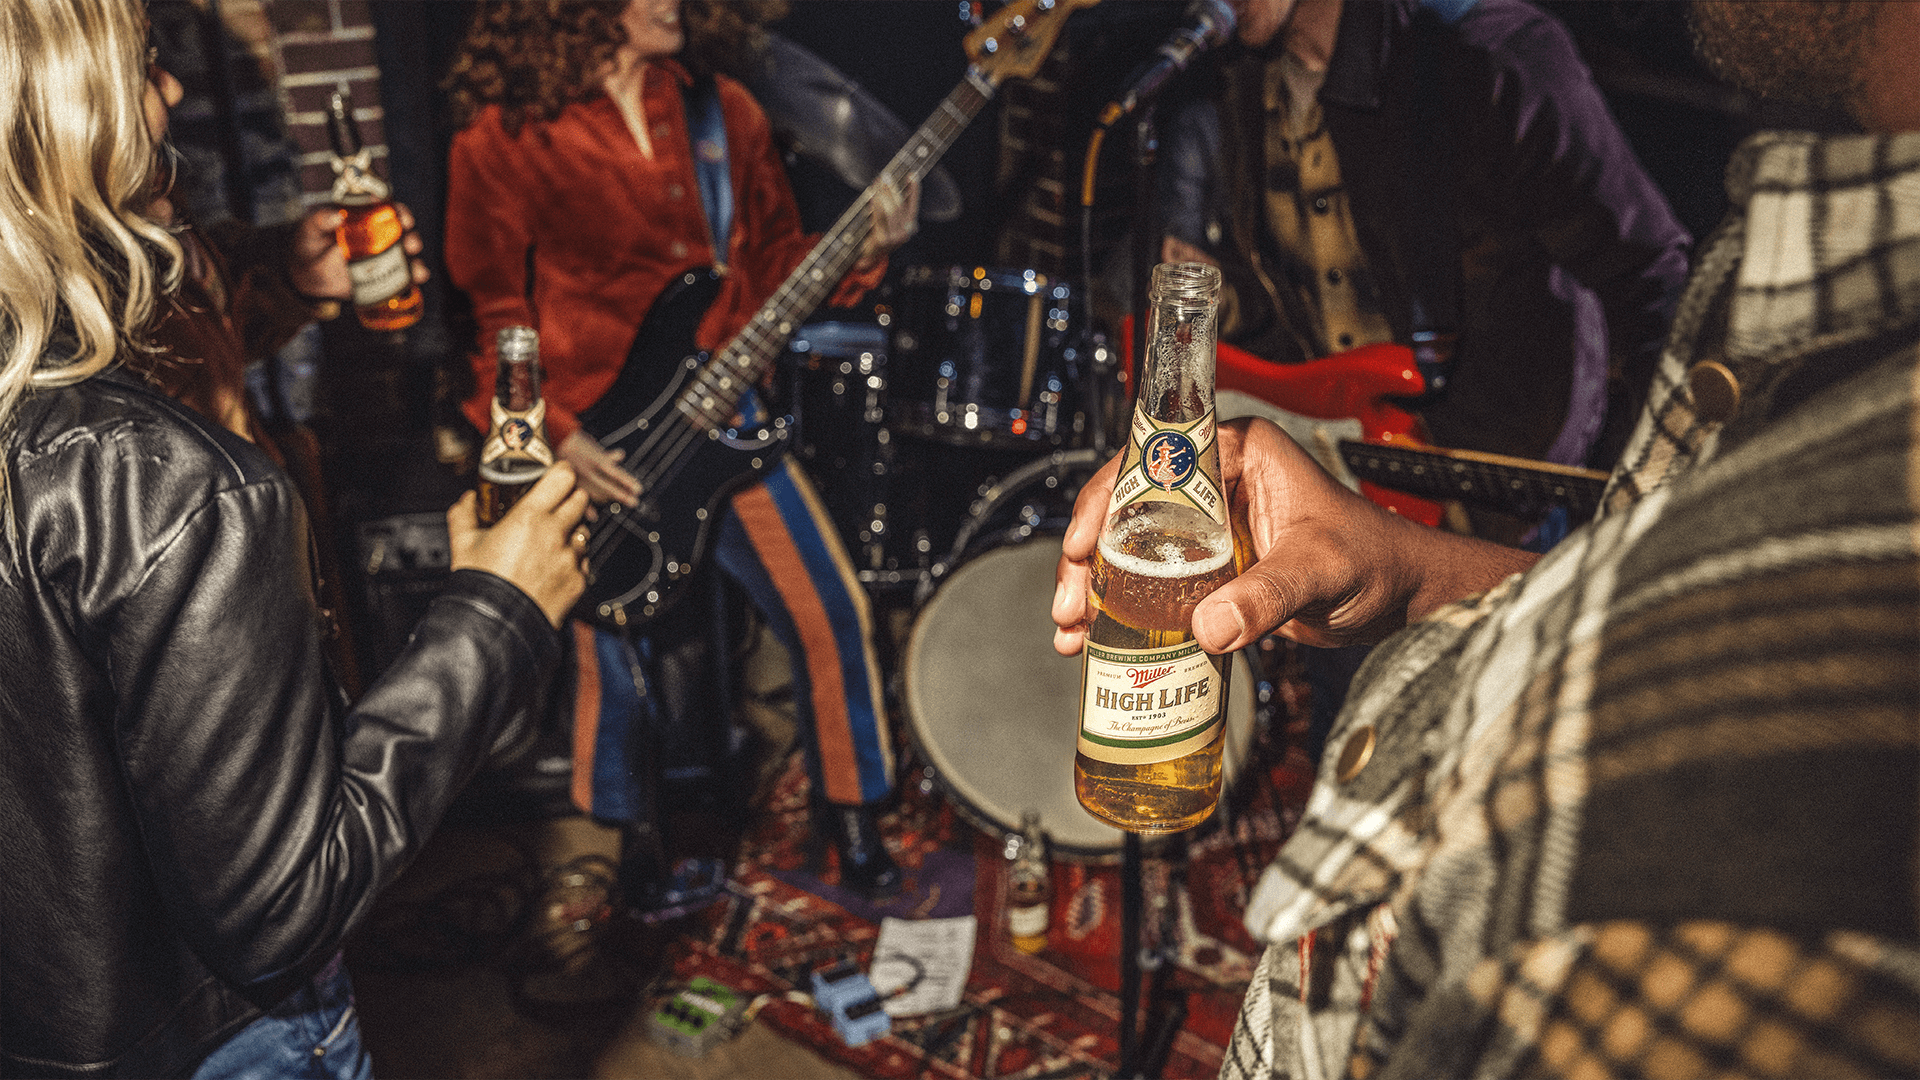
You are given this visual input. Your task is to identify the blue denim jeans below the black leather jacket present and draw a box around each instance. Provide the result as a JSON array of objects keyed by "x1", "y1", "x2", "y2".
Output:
[{"x1": 194, "y1": 955, "x2": 372, "y2": 1080}]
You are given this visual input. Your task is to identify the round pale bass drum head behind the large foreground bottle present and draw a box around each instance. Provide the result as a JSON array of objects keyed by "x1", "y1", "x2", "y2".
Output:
[{"x1": 902, "y1": 534, "x2": 1254, "y2": 863}]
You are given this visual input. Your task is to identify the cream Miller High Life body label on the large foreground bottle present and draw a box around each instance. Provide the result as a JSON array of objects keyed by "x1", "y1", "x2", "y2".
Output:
[{"x1": 1079, "y1": 642, "x2": 1227, "y2": 765}]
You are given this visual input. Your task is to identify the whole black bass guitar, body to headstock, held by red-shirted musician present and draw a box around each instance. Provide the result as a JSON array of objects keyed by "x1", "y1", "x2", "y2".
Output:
[{"x1": 576, "y1": 0, "x2": 1098, "y2": 628}]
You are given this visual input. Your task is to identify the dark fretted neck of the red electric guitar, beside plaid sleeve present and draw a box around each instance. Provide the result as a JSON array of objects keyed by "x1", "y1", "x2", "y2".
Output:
[{"x1": 1340, "y1": 440, "x2": 1607, "y2": 521}]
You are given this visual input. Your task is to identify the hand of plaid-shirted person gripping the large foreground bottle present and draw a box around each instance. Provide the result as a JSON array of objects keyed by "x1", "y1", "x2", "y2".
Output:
[{"x1": 1052, "y1": 419, "x2": 1536, "y2": 655}]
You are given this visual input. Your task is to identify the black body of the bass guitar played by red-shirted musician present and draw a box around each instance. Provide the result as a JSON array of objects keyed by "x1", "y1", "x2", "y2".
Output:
[{"x1": 574, "y1": 271, "x2": 789, "y2": 628}]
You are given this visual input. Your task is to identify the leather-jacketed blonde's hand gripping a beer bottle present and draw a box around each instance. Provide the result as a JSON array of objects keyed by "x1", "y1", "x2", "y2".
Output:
[{"x1": 447, "y1": 461, "x2": 588, "y2": 626}]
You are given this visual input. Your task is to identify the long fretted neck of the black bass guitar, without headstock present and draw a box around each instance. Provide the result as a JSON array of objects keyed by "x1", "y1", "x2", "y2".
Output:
[{"x1": 680, "y1": 67, "x2": 995, "y2": 427}]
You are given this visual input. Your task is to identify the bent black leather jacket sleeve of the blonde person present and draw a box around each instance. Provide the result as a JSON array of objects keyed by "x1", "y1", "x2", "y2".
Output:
[{"x1": 104, "y1": 441, "x2": 559, "y2": 1005}]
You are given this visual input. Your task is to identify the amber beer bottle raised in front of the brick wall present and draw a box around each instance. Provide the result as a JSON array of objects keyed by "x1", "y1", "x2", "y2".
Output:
[{"x1": 326, "y1": 83, "x2": 424, "y2": 331}]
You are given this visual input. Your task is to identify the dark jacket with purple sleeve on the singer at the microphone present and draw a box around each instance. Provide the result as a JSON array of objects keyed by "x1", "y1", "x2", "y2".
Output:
[{"x1": 1164, "y1": 0, "x2": 1692, "y2": 465}]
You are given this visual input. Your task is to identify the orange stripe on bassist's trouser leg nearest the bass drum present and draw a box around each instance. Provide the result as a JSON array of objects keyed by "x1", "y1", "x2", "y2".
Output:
[{"x1": 733, "y1": 484, "x2": 860, "y2": 805}]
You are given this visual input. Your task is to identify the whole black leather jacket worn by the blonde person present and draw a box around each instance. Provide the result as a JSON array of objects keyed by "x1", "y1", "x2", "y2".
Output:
[{"x1": 0, "y1": 371, "x2": 559, "y2": 1076}]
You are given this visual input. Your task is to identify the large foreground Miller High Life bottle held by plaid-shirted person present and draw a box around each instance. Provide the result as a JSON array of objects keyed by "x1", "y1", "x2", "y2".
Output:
[{"x1": 1073, "y1": 263, "x2": 1240, "y2": 832}]
